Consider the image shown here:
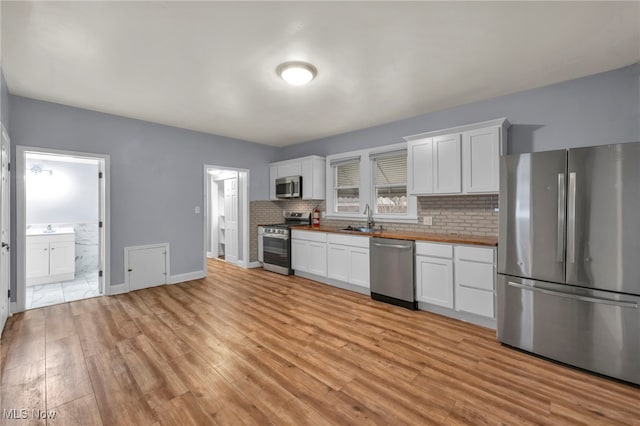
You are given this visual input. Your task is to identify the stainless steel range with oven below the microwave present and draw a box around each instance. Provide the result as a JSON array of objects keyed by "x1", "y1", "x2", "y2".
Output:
[{"x1": 262, "y1": 212, "x2": 309, "y2": 275}]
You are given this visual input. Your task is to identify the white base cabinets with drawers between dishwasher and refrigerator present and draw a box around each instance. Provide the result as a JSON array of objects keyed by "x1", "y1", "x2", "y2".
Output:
[{"x1": 416, "y1": 242, "x2": 496, "y2": 318}]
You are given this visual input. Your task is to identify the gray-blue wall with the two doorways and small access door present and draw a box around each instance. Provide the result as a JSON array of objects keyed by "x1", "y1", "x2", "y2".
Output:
[{"x1": 9, "y1": 96, "x2": 277, "y2": 294}]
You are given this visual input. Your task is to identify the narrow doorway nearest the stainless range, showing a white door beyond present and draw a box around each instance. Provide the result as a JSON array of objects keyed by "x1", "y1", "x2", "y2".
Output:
[{"x1": 204, "y1": 166, "x2": 249, "y2": 271}]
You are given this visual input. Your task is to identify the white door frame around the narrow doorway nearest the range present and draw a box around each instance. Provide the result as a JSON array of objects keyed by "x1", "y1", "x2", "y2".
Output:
[{"x1": 202, "y1": 164, "x2": 250, "y2": 276}]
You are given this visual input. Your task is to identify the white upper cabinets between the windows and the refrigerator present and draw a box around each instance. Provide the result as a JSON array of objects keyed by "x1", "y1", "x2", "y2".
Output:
[{"x1": 405, "y1": 118, "x2": 510, "y2": 195}]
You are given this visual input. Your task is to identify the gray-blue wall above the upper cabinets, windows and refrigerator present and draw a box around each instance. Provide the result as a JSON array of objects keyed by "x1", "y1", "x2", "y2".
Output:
[{"x1": 279, "y1": 64, "x2": 640, "y2": 160}]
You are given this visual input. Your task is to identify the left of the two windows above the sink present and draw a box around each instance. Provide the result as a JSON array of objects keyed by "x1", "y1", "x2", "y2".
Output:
[{"x1": 331, "y1": 158, "x2": 360, "y2": 213}]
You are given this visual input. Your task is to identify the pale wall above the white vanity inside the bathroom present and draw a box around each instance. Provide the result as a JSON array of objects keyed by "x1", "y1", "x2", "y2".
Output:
[{"x1": 25, "y1": 158, "x2": 98, "y2": 225}]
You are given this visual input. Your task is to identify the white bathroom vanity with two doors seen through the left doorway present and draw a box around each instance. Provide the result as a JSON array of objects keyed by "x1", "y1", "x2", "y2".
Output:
[{"x1": 26, "y1": 227, "x2": 76, "y2": 286}]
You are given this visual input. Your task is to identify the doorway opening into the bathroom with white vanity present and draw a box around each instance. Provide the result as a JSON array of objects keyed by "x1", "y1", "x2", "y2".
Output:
[{"x1": 16, "y1": 147, "x2": 108, "y2": 310}]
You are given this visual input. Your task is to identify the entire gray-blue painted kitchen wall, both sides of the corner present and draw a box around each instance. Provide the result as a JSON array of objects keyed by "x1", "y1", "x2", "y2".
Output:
[{"x1": 2, "y1": 64, "x2": 640, "y2": 302}]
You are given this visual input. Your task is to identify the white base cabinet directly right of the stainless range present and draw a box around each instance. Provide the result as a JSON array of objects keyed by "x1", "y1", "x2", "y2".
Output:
[{"x1": 291, "y1": 229, "x2": 327, "y2": 277}]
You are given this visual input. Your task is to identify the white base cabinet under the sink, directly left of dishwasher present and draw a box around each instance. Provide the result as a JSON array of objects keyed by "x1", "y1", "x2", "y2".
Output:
[{"x1": 327, "y1": 234, "x2": 369, "y2": 288}]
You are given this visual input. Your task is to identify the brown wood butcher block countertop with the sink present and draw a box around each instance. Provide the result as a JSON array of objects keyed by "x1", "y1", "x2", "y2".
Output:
[{"x1": 291, "y1": 225, "x2": 498, "y2": 247}]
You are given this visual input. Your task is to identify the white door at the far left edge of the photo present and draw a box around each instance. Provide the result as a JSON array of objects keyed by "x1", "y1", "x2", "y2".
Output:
[{"x1": 0, "y1": 127, "x2": 11, "y2": 334}]
